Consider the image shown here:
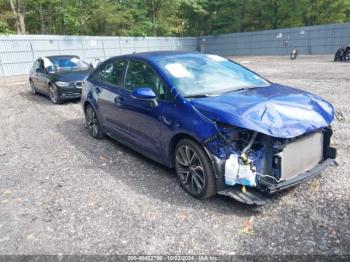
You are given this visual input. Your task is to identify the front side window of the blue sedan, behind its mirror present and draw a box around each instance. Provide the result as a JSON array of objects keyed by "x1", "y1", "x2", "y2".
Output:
[{"x1": 125, "y1": 61, "x2": 166, "y2": 99}]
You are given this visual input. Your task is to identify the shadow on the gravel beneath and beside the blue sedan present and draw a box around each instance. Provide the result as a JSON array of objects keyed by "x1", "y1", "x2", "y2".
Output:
[{"x1": 57, "y1": 118, "x2": 262, "y2": 217}]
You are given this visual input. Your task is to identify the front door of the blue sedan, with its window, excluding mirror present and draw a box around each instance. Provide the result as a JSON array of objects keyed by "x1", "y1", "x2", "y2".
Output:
[{"x1": 119, "y1": 60, "x2": 165, "y2": 156}]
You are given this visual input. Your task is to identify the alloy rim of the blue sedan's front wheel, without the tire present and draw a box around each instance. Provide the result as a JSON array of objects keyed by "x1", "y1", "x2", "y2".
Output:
[{"x1": 176, "y1": 145, "x2": 205, "y2": 195}]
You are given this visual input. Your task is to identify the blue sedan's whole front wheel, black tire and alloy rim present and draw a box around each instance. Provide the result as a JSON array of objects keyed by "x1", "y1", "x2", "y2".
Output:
[{"x1": 174, "y1": 138, "x2": 217, "y2": 199}]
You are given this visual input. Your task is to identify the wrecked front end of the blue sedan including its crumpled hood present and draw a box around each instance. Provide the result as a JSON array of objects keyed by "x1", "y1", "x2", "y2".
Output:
[{"x1": 187, "y1": 84, "x2": 336, "y2": 205}]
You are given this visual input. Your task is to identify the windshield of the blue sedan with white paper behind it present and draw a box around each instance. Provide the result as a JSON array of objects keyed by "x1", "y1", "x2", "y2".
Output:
[{"x1": 157, "y1": 54, "x2": 270, "y2": 97}]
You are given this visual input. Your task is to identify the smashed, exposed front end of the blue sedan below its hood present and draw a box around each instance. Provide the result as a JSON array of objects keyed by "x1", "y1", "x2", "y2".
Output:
[{"x1": 203, "y1": 122, "x2": 336, "y2": 205}]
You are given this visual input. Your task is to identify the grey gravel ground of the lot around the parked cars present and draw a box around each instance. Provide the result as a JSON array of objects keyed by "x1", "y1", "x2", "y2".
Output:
[{"x1": 0, "y1": 56, "x2": 350, "y2": 255}]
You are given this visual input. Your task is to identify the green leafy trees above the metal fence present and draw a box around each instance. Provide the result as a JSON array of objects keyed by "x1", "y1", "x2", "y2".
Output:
[{"x1": 0, "y1": 0, "x2": 350, "y2": 36}]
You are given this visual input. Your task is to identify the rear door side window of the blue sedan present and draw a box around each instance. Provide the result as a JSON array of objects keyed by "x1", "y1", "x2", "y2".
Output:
[{"x1": 97, "y1": 60, "x2": 126, "y2": 86}]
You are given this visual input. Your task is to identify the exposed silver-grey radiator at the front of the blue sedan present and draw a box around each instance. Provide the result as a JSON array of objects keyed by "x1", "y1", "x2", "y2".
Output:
[{"x1": 280, "y1": 132, "x2": 323, "y2": 180}]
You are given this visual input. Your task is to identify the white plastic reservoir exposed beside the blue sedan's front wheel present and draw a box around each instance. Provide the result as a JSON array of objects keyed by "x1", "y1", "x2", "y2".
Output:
[{"x1": 225, "y1": 154, "x2": 256, "y2": 187}]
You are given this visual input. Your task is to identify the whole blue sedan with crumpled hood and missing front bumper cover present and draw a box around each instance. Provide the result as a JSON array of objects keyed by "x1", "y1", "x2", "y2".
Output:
[{"x1": 82, "y1": 51, "x2": 336, "y2": 205}]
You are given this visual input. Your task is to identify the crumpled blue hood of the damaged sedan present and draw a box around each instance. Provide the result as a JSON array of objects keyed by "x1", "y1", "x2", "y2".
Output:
[{"x1": 191, "y1": 84, "x2": 334, "y2": 138}]
